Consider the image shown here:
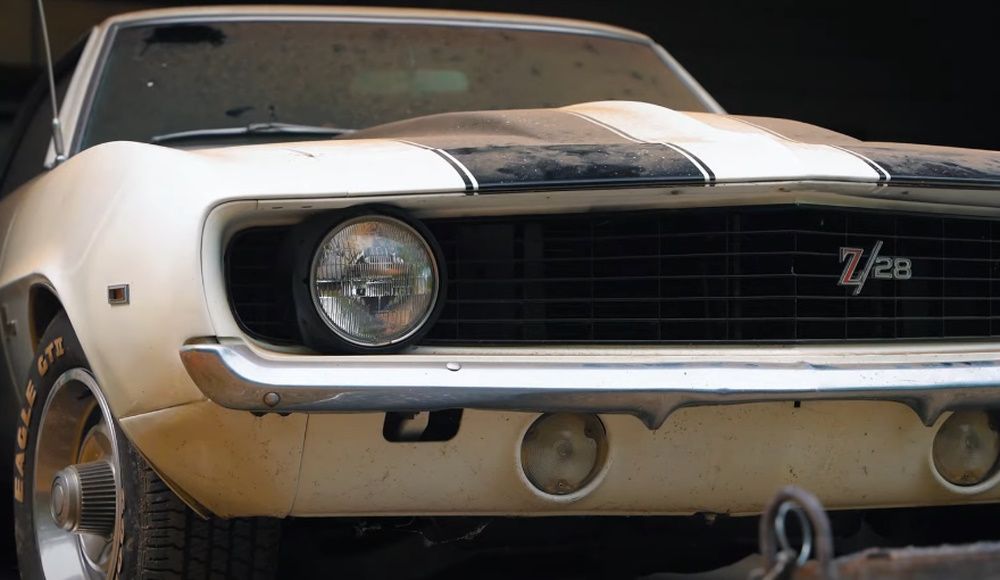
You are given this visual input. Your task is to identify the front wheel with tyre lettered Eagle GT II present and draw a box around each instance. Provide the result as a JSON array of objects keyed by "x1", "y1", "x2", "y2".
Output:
[{"x1": 13, "y1": 314, "x2": 280, "y2": 579}]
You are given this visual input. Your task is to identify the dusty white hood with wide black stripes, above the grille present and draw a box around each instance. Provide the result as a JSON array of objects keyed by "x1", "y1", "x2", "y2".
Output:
[{"x1": 334, "y1": 102, "x2": 1000, "y2": 193}]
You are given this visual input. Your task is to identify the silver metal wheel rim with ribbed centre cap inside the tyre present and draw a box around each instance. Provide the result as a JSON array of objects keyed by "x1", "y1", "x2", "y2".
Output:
[{"x1": 33, "y1": 369, "x2": 122, "y2": 580}]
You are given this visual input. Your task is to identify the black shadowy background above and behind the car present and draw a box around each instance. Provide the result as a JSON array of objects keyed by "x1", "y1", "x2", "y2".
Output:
[{"x1": 0, "y1": 0, "x2": 1000, "y2": 149}]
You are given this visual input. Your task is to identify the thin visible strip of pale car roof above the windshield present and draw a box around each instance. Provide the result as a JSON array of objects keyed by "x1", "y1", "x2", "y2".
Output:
[{"x1": 100, "y1": 5, "x2": 650, "y2": 43}]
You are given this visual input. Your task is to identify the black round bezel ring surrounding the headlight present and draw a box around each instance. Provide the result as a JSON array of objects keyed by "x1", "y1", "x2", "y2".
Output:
[{"x1": 293, "y1": 206, "x2": 446, "y2": 354}]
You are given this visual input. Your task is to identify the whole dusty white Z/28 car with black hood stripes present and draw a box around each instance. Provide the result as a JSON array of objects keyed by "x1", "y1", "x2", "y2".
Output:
[{"x1": 0, "y1": 7, "x2": 1000, "y2": 578}]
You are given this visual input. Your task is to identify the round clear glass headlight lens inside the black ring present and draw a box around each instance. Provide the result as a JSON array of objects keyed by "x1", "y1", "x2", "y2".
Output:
[{"x1": 311, "y1": 215, "x2": 440, "y2": 347}]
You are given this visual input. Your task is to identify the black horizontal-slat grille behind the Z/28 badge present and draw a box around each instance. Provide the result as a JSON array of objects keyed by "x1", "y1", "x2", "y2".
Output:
[{"x1": 230, "y1": 207, "x2": 1000, "y2": 345}]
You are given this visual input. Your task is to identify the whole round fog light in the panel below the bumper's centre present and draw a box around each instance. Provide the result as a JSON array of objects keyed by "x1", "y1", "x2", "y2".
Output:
[{"x1": 521, "y1": 413, "x2": 608, "y2": 495}]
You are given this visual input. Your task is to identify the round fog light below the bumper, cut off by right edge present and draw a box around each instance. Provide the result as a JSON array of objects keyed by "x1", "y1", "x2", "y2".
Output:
[{"x1": 932, "y1": 411, "x2": 1000, "y2": 486}]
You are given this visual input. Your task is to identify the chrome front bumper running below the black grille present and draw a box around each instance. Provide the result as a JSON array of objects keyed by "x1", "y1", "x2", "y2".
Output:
[{"x1": 174, "y1": 339, "x2": 1000, "y2": 429}]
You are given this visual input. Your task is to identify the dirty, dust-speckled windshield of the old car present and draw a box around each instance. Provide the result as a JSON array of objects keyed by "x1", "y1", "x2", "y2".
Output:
[{"x1": 81, "y1": 20, "x2": 705, "y2": 148}]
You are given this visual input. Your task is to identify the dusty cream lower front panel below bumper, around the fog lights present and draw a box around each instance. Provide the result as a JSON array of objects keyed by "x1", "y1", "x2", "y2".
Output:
[{"x1": 292, "y1": 402, "x2": 1000, "y2": 515}]
